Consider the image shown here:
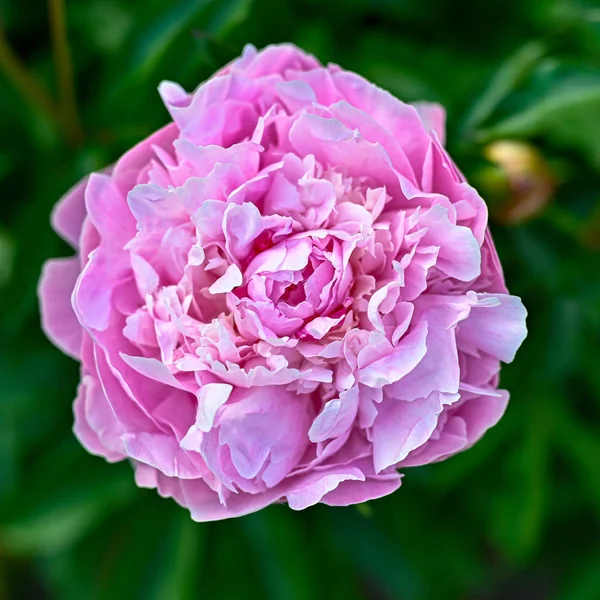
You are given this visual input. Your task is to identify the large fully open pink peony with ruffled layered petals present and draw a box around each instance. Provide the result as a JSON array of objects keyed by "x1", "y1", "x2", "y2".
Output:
[{"x1": 39, "y1": 45, "x2": 526, "y2": 521}]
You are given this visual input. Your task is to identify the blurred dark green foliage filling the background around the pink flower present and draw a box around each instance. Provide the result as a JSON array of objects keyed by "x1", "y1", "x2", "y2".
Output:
[{"x1": 0, "y1": 0, "x2": 600, "y2": 600}]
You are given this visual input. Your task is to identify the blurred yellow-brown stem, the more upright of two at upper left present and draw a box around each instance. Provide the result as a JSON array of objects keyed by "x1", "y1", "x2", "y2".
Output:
[{"x1": 48, "y1": 0, "x2": 83, "y2": 144}]
